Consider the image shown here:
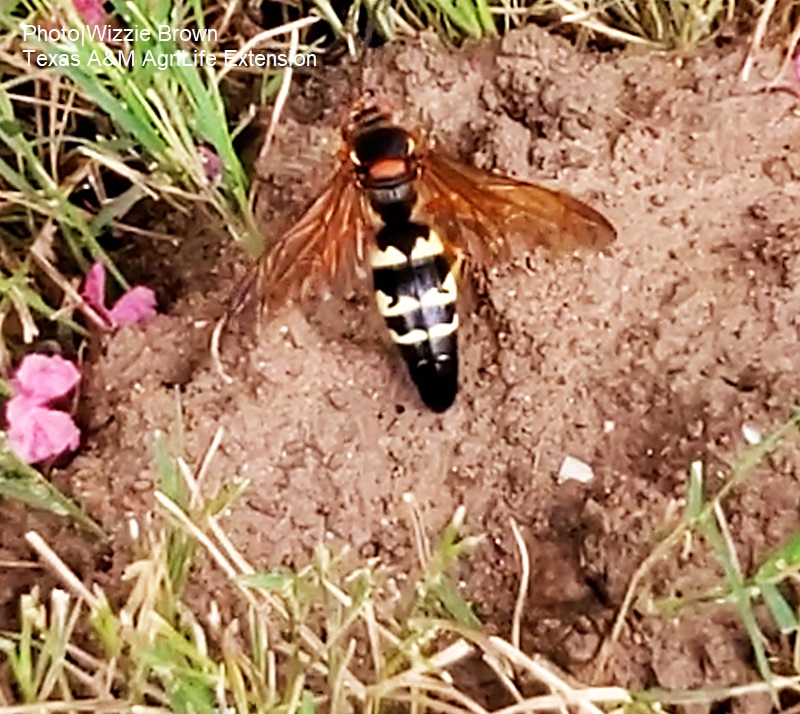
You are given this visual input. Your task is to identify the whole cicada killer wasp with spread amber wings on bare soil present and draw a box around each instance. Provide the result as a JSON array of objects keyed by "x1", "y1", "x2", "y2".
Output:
[{"x1": 259, "y1": 96, "x2": 616, "y2": 412}]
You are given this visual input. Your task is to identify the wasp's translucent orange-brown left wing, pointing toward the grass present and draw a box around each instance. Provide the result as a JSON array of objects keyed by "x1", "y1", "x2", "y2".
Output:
[{"x1": 259, "y1": 164, "x2": 368, "y2": 311}]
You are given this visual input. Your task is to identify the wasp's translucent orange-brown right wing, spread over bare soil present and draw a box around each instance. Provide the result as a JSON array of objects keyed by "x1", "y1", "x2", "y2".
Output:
[{"x1": 419, "y1": 151, "x2": 616, "y2": 263}]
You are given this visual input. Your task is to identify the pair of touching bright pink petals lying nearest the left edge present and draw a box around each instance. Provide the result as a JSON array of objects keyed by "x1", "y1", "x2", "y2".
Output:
[{"x1": 6, "y1": 354, "x2": 81, "y2": 464}]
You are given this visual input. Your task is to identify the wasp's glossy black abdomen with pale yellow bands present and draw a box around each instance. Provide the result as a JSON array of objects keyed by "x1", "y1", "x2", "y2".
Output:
[{"x1": 370, "y1": 221, "x2": 458, "y2": 412}]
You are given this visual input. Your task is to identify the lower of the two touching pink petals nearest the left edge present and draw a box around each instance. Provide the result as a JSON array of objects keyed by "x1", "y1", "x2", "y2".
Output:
[{"x1": 6, "y1": 396, "x2": 81, "y2": 464}]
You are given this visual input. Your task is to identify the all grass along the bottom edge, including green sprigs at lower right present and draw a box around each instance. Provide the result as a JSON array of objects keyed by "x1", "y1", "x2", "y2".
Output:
[{"x1": 7, "y1": 421, "x2": 800, "y2": 714}]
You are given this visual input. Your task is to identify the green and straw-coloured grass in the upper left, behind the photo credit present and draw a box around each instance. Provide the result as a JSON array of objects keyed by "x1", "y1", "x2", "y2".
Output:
[{"x1": 0, "y1": 0, "x2": 310, "y2": 371}]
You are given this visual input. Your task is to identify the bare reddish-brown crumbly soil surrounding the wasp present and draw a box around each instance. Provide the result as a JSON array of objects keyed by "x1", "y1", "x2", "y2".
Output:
[{"x1": 0, "y1": 28, "x2": 800, "y2": 712}]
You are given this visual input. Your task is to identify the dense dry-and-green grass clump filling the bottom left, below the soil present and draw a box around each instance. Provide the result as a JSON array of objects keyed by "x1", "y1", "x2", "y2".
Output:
[{"x1": 0, "y1": 426, "x2": 627, "y2": 714}]
